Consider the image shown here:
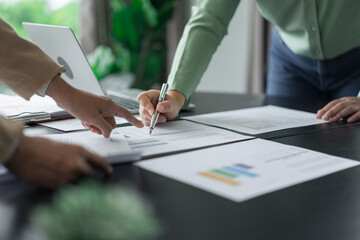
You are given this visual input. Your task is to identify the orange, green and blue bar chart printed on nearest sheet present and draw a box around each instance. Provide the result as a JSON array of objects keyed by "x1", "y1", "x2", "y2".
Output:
[{"x1": 199, "y1": 163, "x2": 259, "y2": 186}]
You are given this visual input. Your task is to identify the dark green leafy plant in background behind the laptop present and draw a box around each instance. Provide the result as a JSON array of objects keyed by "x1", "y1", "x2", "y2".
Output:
[{"x1": 90, "y1": 0, "x2": 179, "y2": 89}]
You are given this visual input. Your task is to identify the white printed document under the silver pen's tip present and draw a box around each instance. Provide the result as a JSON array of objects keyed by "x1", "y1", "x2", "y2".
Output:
[{"x1": 112, "y1": 120, "x2": 253, "y2": 156}]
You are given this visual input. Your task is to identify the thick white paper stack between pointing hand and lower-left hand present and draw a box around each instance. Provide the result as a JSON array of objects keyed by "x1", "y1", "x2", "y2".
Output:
[{"x1": 42, "y1": 131, "x2": 141, "y2": 163}]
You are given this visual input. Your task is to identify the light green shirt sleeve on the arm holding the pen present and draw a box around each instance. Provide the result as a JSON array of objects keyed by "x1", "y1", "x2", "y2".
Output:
[{"x1": 168, "y1": 0, "x2": 239, "y2": 105}]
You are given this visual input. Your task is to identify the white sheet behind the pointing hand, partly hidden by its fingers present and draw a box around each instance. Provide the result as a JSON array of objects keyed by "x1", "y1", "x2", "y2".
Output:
[{"x1": 39, "y1": 115, "x2": 141, "y2": 132}]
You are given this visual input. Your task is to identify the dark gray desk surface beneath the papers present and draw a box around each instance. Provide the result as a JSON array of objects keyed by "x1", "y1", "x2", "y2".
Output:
[{"x1": 0, "y1": 93, "x2": 360, "y2": 240}]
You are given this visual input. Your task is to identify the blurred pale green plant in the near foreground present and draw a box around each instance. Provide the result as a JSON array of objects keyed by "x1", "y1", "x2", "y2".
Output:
[{"x1": 31, "y1": 182, "x2": 164, "y2": 240}]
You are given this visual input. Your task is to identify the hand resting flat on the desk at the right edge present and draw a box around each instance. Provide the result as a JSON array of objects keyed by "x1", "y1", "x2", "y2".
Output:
[{"x1": 316, "y1": 97, "x2": 360, "y2": 123}]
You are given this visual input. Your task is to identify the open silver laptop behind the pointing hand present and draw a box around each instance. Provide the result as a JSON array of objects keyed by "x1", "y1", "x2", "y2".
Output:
[{"x1": 23, "y1": 22, "x2": 141, "y2": 114}]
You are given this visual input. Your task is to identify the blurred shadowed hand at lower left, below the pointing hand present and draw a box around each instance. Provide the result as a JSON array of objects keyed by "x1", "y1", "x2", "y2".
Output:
[{"x1": 5, "y1": 135, "x2": 112, "y2": 189}]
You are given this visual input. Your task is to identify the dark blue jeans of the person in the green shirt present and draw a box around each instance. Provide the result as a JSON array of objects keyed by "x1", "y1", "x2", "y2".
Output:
[{"x1": 266, "y1": 28, "x2": 360, "y2": 100}]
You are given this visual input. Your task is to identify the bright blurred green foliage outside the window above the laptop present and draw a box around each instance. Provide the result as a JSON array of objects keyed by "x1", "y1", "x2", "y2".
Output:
[{"x1": 0, "y1": 0, "x2": 80, "y2": 39}]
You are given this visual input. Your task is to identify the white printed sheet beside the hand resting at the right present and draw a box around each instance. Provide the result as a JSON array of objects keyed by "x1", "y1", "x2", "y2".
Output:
[{"x1": 184, "y1": 105, "x2": 325, "y2": 135}]
